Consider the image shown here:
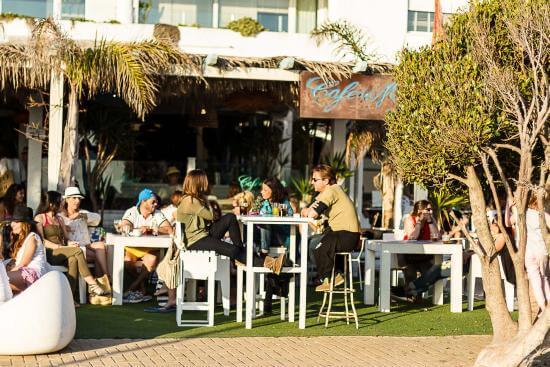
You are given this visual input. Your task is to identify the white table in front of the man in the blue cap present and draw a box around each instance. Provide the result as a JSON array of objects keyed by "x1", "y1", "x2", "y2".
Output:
[{"x1": 105, "y1": 233, "x2": 172, "y2": 306}]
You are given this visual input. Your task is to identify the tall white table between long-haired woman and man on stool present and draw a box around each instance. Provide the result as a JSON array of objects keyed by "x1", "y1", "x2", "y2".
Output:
[{"x1": 237, "y1": 215, "x2": 312, "y2": 329}]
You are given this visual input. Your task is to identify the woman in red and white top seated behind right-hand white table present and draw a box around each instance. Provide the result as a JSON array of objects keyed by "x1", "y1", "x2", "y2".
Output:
[{"x1": 403, "y1": 200, "x2": 441, "y2": 284}]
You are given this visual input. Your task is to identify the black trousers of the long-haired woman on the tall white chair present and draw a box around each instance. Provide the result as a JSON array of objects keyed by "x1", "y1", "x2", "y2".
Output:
[{"x1": 189, "y1": 214, "x2": 264, "y2": 266}]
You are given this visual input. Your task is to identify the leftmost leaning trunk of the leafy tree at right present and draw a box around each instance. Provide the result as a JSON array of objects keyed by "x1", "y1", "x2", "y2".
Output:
[{"x1": 467, "y1": 166, "x2": 517, "y2": 343}]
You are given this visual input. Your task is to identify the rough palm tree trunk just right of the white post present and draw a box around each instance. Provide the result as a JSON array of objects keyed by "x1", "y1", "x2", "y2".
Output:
[{"x1": 57, "y1": 85, "x2": 78, "y2": 192}]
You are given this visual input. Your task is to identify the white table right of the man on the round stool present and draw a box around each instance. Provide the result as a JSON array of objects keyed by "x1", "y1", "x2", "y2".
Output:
[{"x1": 364, "y1": 241, "x2": 462, "y2": 312}]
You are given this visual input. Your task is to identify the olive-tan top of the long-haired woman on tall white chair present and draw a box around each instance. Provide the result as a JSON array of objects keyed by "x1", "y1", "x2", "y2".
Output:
[{"x1": 176, "y1": 196, "x2": 214, "y2": 246}]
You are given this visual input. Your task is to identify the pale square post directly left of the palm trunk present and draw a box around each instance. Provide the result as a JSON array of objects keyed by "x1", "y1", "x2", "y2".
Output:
[{"x1": 47, "y1": 72, "x2": 63, "y2": 190}]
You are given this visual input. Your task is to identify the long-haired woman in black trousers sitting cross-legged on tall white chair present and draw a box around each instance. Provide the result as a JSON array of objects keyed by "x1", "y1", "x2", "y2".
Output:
[{"x1": 145, "y1": 169, "x2": 285, "y2": 312}]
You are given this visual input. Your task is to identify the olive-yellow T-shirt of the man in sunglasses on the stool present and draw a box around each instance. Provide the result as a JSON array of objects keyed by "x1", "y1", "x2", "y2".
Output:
[{"x1": 316, "y1": 184, "x2": 360, "y2": 232}]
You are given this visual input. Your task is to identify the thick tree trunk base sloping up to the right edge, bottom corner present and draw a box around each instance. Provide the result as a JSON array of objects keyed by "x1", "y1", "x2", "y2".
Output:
[{"x1": 474, "y1": 307, "x2": 550, "y2": 367}]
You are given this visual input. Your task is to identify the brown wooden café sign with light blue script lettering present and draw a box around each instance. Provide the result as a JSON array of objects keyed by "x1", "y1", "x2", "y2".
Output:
[{"x1": 300, "y1": 72, "x2": 396, "y2": 120}]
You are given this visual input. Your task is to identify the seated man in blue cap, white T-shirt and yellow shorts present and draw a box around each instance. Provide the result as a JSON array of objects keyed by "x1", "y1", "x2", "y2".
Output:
[{"x1": 121, "y1": 189, "x2": 172, "y2": 303}]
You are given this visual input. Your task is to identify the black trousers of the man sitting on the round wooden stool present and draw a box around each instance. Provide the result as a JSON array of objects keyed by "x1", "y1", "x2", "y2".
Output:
[{"x1": 313, "y1": 231, "x2": 360, "y2": 279}]
